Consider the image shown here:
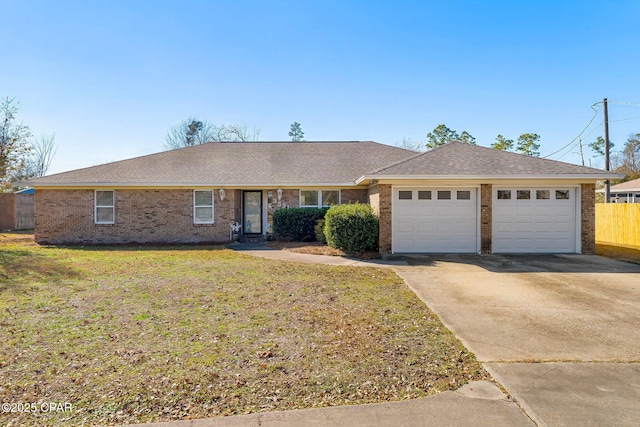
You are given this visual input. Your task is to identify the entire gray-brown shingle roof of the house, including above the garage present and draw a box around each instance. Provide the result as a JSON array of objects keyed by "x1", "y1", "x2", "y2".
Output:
[{"x1": 24, "y1": 141, "x2": 616, "y2": 187}]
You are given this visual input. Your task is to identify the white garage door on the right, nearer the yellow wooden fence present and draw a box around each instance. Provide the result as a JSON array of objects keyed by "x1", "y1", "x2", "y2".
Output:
[{"x1": 492, "y1": 187, "x2": 577, "y2": 253}]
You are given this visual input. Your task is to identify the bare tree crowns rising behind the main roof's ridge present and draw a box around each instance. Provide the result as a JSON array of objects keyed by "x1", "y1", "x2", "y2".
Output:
[{"x1": 164, "y1": 117, "x2": 260, "y2": 150}]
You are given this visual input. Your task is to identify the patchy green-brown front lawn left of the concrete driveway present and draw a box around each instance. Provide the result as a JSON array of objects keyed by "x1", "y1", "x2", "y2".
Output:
[{"x1": 0, "y1": 234, "x2": 488, "y2": 425}]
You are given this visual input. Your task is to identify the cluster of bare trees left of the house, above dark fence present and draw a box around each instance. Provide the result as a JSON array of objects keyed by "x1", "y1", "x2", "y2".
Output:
[{"x1": 0, "y1": 97, "x2": 56, "y2": 191}]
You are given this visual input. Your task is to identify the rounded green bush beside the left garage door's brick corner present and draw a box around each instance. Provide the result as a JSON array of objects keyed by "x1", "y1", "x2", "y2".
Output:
[{"x1": 324, "y1": 203, "x2": 378, "y2": 254}]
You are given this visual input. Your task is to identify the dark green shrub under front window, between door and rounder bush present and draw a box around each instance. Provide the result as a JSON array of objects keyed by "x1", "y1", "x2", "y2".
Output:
[{"x1": 273, "y1": 208, "x2": 327, "y2": 242}]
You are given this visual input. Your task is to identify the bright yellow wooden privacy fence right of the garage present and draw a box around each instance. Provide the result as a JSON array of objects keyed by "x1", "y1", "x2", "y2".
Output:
[{"x1": 596, "y1": 203, "x2": 640, "y2": 247}]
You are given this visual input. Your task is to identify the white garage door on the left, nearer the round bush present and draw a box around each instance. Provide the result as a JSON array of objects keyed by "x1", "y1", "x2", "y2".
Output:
[{"x1": 392, "y1": 188, "x2": 478, "y2": 253}]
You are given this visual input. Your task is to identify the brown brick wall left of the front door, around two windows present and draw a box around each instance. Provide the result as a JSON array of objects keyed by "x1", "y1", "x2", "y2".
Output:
[{"x1": 35, "y1": 189, "x2": 240, "y2": 244}]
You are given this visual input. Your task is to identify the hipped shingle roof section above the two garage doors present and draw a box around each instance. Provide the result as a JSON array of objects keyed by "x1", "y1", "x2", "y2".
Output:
[{"x1": 366, "y1": 142, "x2": 618, "y2": 179}]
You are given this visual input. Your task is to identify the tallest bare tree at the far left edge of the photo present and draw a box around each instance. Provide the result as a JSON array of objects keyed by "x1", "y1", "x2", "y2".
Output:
[{"x1": 0, "y1": 97, "x2": 31, "y2": 190}]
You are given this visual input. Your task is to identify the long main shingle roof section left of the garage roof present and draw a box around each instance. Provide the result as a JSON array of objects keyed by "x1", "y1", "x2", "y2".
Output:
[{"x1": 25, "y1": 141, "x2": 414, "y2": 187}]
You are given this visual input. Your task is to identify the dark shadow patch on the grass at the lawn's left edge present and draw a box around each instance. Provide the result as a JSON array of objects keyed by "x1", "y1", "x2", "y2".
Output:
[{"x1": 0, "y1": 248, "x2": 84, "y2": 293}]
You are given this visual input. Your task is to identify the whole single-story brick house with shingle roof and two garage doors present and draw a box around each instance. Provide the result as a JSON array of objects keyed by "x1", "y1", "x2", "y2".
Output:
[{"x1": 18, "y1": 142, "x2": 619, "y2": 253}]
